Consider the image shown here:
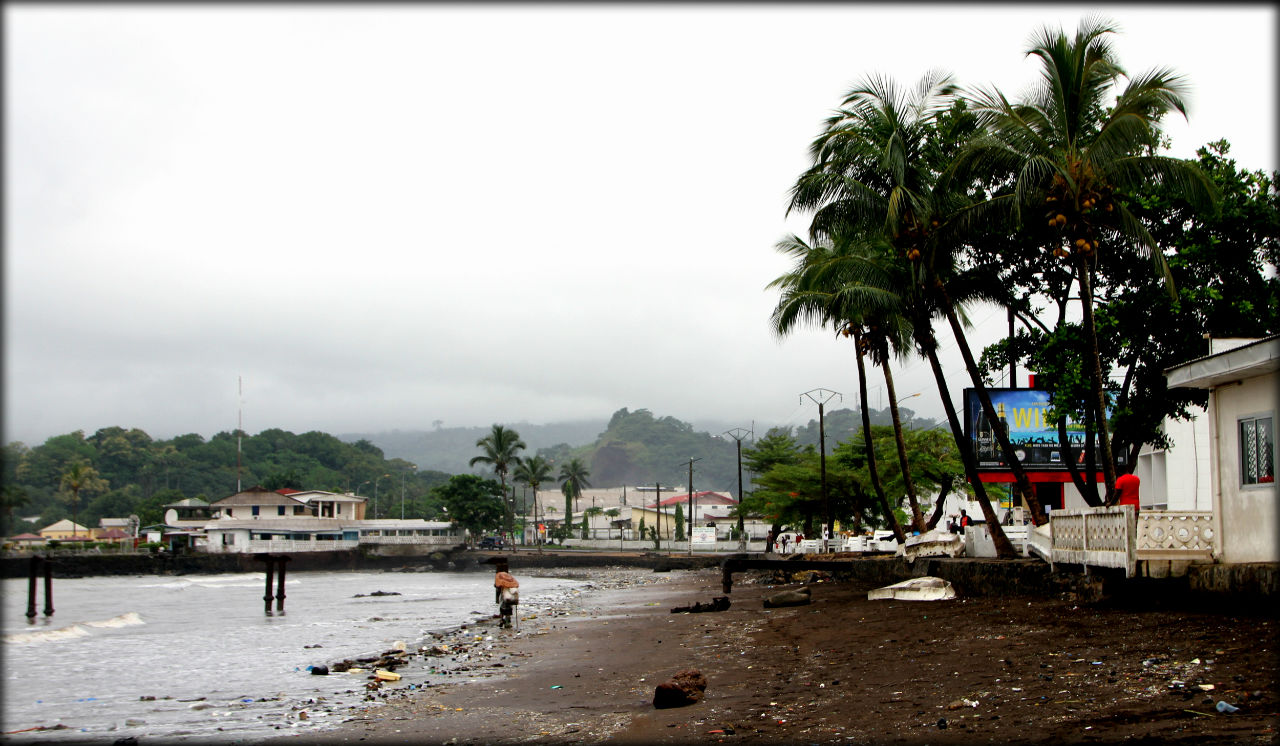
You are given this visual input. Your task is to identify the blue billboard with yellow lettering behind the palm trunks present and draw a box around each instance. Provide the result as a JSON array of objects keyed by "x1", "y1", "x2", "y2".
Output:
[{"x1": 964, "y1": 389, "x2": 1125, "y2": 471}]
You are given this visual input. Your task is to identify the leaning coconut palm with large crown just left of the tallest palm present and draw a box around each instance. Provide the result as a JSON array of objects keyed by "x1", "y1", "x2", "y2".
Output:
[{"x1": 791, "y1": 74, "x2": 1039, "y2": 555}]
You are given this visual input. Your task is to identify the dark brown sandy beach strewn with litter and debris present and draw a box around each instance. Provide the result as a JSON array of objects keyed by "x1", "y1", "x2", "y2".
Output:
[{"x1": 275, "y1": 568, "x2": 1280, "y2": 743}]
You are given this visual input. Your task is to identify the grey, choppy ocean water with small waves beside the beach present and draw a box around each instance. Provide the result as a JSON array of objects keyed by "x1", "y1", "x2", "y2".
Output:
[{"x1": 0, "y1": 571, "x2": 584, "y2": 743}]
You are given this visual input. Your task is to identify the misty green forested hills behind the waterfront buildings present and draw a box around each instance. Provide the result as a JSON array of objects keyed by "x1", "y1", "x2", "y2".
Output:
[{"x1": 0, "y1": 408, "x2": 932, "y2": 535}]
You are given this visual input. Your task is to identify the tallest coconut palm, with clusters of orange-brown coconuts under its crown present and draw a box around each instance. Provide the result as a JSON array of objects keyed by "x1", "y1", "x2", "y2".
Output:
[{"x1": 952, "y1": 18, "x2": 1216, "y2": 503}]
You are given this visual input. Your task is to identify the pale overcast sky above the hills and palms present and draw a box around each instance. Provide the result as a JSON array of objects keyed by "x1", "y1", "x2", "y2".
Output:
[{"x1": 4, "y1": 4, "x2": 1276, "y2": 444}]
